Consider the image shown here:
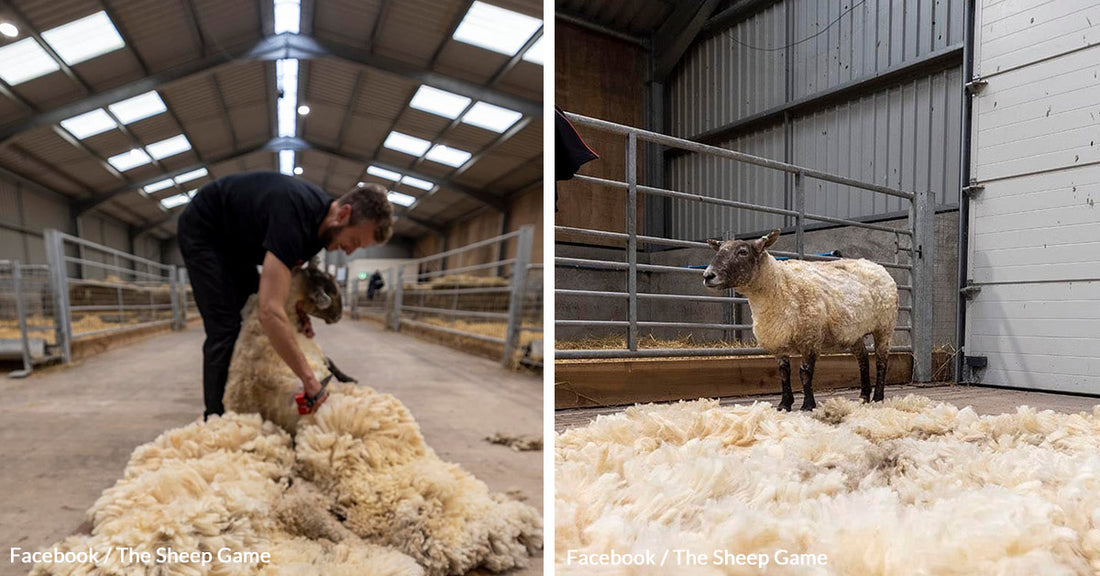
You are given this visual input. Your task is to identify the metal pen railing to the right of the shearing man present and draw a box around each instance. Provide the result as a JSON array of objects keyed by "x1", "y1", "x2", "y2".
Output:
[{"x1": 349, "y1": 225, "x2": 542, "y2": 366}]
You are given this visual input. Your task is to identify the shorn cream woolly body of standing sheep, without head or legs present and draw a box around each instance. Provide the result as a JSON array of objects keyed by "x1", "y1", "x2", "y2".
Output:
[{"x1": 738, "y1": 254, "x2": 898, "y2": 356}]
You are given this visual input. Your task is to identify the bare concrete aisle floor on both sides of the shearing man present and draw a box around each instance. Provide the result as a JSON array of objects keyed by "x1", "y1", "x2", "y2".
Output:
[{"x1": 0, "y1": 320, "x2": 542, "y2": 576}]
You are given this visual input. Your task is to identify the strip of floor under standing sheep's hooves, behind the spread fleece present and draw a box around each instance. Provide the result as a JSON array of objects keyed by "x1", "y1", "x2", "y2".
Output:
[{"x1": 554, "y1": 384, "x2": 1100, "y2": 432}]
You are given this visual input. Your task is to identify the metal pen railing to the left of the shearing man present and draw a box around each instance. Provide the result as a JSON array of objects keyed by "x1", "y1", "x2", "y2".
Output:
[{"x1": 45, "y1": 230, "x2": 186, "y2": 362}]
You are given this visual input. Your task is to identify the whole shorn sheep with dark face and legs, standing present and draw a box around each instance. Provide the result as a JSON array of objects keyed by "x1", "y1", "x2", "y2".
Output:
[{"x1": 703, "y1": 230, "x2": 898, "y2": 410}]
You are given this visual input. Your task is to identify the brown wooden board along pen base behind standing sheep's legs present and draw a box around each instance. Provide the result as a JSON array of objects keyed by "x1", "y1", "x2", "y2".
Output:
[{"x1": 554, "y1": 353, "x2": 946, "y2": 410}]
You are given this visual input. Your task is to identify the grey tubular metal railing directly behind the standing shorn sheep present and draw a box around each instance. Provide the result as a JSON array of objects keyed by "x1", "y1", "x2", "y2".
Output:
[{"x1": 554, "y1": 112, "x2": 934, "y2": 381}]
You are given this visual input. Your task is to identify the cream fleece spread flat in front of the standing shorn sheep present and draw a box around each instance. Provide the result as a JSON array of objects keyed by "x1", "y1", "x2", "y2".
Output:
[{"x1": 556, "y1": 396, "x2": 1100, "y2": 576}]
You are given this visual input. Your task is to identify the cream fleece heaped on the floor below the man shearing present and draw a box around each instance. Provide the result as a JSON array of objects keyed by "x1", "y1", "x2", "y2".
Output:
[{"x1": 31, "y1": 385, "x2": 542, "y2": 576}]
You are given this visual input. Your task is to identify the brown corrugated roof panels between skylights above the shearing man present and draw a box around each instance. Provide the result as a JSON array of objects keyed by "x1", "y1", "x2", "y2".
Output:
[{"x1": 0, "y1": 0, "x2": 542, "y2": 234}]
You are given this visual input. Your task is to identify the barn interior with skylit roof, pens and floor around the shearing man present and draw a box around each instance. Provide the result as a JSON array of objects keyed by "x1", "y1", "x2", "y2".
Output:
[{"x1": 0, "y1": 0, "x2": 546, "y2": 574}]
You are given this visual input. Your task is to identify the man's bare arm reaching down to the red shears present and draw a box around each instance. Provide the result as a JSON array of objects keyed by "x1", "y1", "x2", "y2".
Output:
[{"x1": 259, "y1": 252, "x2": 321, "y2": 396}]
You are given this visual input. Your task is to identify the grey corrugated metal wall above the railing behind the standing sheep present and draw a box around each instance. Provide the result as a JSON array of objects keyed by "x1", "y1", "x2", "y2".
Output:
[{"x1": 668, "y1": 0, "x2": 963, "y2": 240}]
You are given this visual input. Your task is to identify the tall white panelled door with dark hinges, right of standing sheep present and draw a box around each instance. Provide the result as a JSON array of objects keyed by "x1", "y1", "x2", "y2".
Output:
[{"x1": 963, "y1": 0, "x2": 1100, "y2": 394}]
